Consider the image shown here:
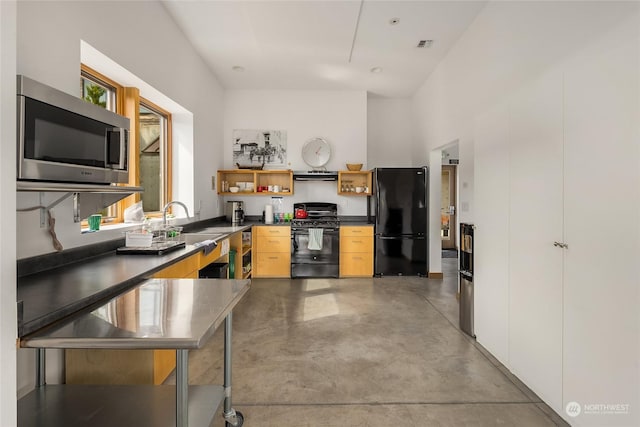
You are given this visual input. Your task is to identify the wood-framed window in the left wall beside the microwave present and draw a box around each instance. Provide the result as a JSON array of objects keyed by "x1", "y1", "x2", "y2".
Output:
[{"x1": 80, "y1": 65, "x2": 171, "y2": 226}]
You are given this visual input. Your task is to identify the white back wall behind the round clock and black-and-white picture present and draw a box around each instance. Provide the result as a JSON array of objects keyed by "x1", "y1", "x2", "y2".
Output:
[{"x1": 223, "y1": 90, "x2": 370, "y2": 215}]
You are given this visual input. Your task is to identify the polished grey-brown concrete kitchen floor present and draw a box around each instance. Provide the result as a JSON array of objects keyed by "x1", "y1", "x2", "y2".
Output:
[{"x1": 172, "y1": 258, "x2": 567, "y2": 427}]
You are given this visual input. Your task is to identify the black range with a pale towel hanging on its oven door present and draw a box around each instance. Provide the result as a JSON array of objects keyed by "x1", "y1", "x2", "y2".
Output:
[{"x1": 291, "y1": 202, "x2": 340, "y2": 278}]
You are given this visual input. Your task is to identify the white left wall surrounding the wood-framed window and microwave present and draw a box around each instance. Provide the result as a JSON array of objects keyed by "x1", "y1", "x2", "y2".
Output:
[{"x1": 17, "y1": 1, "x2": 223, "y2": 258}]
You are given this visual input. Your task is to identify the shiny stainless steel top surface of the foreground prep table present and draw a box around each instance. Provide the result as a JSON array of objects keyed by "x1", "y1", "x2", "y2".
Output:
[{"x1": 20, "y1": 279, "x2": 251, "y2": 349}]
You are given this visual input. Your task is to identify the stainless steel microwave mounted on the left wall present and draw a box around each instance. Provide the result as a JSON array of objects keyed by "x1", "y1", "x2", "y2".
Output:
[{"x1": 17, "y1": 75, "x2": 129, "y2": 184}]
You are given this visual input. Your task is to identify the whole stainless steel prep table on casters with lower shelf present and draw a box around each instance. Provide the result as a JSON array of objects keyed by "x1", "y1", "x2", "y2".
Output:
[{"x1": 18, "y1": 279, "x2": 250, "y2": 427}]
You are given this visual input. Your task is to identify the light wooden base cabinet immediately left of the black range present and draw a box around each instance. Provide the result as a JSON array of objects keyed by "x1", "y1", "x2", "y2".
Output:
[{"x1": 251, "y1": 225, "x2": 291, "y2": 278}]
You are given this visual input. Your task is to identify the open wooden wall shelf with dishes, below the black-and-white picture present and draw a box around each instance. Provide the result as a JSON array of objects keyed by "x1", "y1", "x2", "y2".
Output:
[{"x1": 216, "y1": 169, "x2": 293, "y2": 196}]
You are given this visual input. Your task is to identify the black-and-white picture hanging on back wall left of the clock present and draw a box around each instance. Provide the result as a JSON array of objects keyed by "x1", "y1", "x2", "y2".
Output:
[{"x1": 233, "y1": 129, "x2": 287, "y2": 169}]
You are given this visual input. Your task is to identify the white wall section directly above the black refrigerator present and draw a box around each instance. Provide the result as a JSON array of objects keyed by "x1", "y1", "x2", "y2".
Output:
[{"x1": 367, "y1": 96, "x2": 416, "y2": 169}]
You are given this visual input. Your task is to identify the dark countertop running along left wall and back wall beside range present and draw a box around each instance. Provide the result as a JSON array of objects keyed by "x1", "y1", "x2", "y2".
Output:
[{"x1": 17, "y1": 217, "x2": 373, "y2": 337}]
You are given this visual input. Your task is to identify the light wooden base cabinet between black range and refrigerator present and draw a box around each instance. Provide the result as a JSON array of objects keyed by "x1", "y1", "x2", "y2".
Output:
[{"x1": 340, "y1": 225, "x2": 373, "y2": 277}]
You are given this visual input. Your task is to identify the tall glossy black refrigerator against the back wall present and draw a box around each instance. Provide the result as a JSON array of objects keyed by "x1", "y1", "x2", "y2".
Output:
[{"x1": 373, "y1": 166, "x2": 429, "y2": 276}]
